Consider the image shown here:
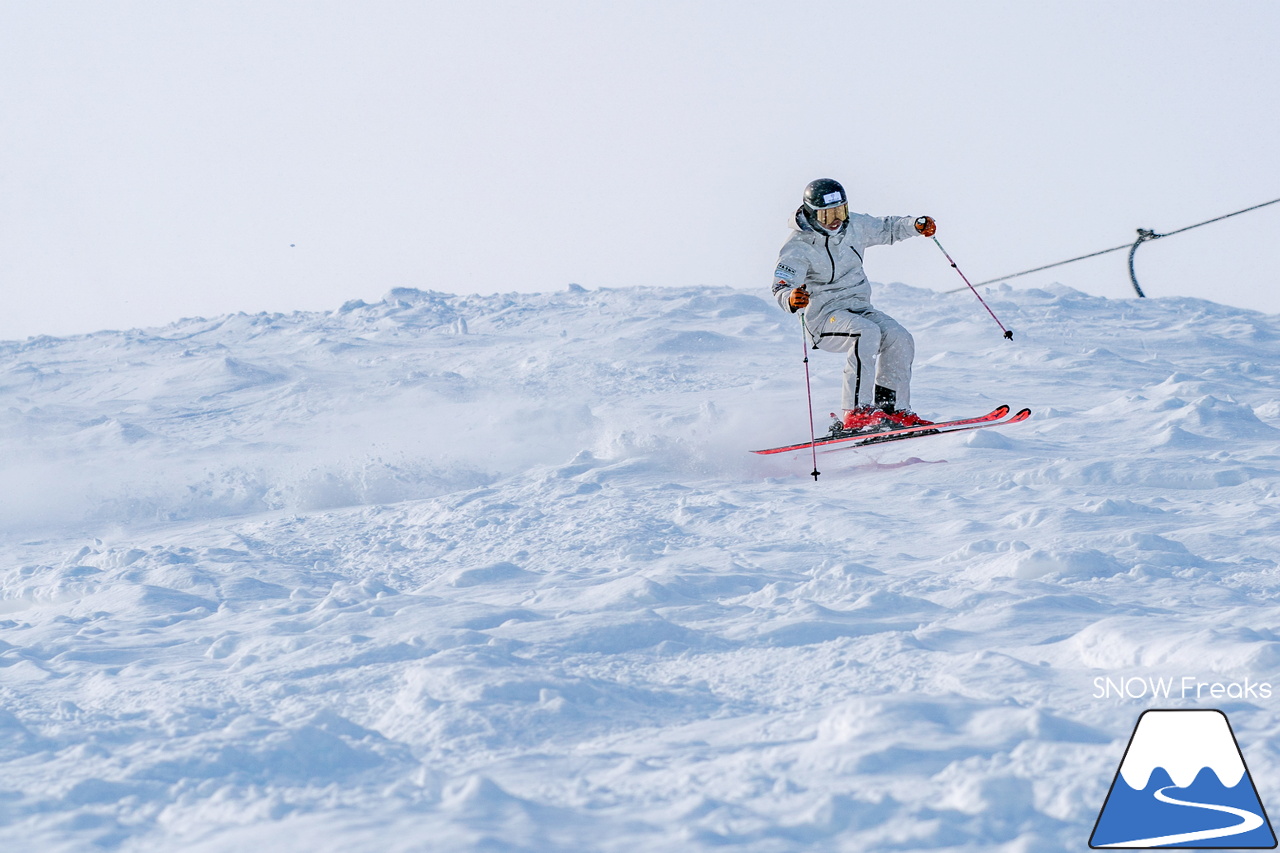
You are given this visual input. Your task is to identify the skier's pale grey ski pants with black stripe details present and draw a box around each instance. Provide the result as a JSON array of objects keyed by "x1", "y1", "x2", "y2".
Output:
[{"x1": 809, "y1": 309, "x2": 915, "y2": 410}]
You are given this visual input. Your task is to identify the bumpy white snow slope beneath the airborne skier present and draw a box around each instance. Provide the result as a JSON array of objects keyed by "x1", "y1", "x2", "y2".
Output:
[{"x1": 0, "y1": 286, "x2": 1280, "y2": 853}]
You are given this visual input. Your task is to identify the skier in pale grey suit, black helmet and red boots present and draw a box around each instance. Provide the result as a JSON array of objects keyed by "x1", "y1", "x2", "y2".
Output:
[{"x1": 773, "y1": 178, "x2": 937, "y2": 432}]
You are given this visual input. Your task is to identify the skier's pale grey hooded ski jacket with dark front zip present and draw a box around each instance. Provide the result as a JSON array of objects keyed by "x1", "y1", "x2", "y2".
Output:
[{"x1": 773, "y1": 207, "x2": 919, "y2": 339}]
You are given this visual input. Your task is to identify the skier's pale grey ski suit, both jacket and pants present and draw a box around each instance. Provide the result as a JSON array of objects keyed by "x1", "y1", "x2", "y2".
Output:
[{"x1": 773, "y1": 207, "x2": 919, "y2": 410}]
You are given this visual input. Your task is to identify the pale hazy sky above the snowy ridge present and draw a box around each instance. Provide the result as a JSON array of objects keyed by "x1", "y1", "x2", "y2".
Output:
[{"x1": 0, "y1": 0, "x2": 1280, "y2": 339}]
